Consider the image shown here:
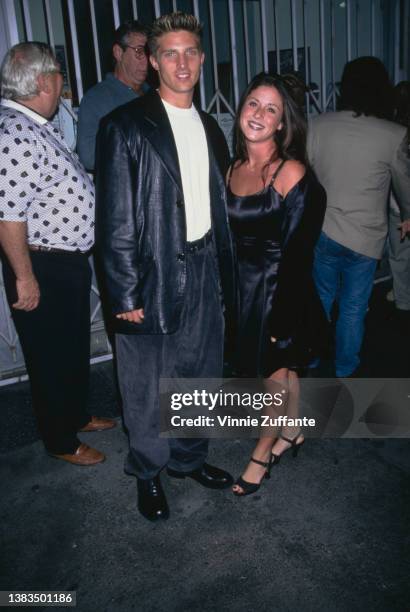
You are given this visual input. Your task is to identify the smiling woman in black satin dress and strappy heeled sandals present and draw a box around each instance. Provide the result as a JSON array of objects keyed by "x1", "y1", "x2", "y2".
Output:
[{"x1": 227, "y1": 73, "x2": 327, "y2": 495}]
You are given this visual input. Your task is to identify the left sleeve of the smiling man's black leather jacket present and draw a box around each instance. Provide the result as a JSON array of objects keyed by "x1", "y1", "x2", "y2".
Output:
[{"x1": 96, "y1": 117, "x2": 143, "y2": 314}]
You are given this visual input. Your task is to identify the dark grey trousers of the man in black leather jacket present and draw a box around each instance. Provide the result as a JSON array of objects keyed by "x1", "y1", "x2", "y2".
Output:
[{"x1": 116, "y1": 243, "x2": 224, "y2": 479}]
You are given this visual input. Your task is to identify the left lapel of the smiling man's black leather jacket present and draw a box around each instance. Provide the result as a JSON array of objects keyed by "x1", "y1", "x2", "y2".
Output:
[{"x1": 144, "y1": 91, "x2": 182, "y2": 194}]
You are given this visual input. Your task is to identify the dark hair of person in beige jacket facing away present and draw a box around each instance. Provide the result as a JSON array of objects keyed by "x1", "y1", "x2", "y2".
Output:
[{"x1": 339, "y1": 56, "x2": 393, "y2": 119}]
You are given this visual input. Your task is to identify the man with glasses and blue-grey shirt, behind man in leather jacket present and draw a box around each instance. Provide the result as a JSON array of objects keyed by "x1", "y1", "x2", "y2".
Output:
[{"x1": 77, "y1": 21, "x2": 148, "y2": 172}]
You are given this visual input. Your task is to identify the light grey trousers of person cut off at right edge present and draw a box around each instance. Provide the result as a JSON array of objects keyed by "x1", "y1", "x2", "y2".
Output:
[{"x1": 389, "y1": 209, "x2": 410, "y2": 310}]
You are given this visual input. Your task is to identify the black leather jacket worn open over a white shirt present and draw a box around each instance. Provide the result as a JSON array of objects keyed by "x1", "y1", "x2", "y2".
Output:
[{"x1": 96, "y1": 91, "x2": 235, "y2": 334}]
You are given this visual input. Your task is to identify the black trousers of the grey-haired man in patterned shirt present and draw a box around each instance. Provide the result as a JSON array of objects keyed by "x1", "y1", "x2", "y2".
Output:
[{"x1": 3, "y1": 252, "x2": 91, "y2": 454}]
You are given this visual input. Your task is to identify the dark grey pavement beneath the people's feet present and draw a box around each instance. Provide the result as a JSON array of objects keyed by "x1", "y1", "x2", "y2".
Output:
[{"x1": 0, "y1": 286, "x2": 410, "y2": 612}]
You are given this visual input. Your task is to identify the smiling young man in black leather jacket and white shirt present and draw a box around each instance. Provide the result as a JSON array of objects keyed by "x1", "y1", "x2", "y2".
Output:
[{"x1": 97, "y1": 13, "x2": 234, "y2": 520}]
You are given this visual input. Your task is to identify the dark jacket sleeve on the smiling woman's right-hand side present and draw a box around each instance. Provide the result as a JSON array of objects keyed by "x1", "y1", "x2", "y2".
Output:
[{"x1": 269, "y1": 171, "x2": 326, "y2": 348}]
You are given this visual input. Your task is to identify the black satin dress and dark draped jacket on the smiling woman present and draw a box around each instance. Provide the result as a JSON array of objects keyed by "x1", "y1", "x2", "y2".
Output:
[{"x1": 228, "y1": 164, "x2": 328, "y2": 377}]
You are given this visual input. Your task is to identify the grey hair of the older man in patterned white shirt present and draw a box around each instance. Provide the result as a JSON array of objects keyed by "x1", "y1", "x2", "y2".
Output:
[{"x1": 0, "y1": 42, "x2": 59, "y2": 100}]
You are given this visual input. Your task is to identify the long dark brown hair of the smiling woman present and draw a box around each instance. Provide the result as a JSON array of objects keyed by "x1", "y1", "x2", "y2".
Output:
[{"x1": 234, "y1": 72, "x2": 308, "y2": 166}]
